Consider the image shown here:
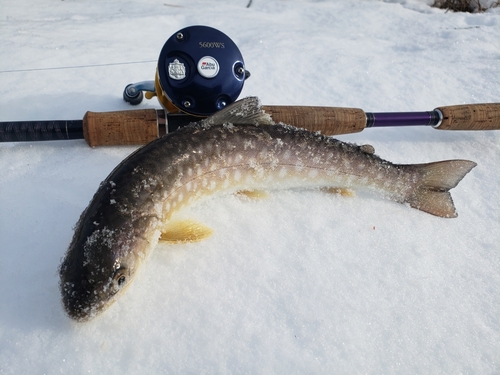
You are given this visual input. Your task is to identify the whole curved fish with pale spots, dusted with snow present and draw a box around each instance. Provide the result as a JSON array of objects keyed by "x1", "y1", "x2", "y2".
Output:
[{"x1": 59, "y1": 97, "x2": 476, "y2": 322}]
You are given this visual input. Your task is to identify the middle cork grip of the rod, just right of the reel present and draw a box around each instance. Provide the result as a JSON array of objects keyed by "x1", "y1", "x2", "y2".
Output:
[{"x1": 262, "y1": 105, "x2": 366, "y2": 135}]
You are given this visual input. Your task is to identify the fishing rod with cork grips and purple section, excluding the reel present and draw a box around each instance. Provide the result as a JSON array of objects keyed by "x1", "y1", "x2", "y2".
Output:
[{"x1": 0, "y1": 103, "x2": 500, "y2": 147}]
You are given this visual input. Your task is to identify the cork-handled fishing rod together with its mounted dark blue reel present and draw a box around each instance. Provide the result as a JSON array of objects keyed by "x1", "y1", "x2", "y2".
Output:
[{"x1": 0, "y1": 26, "x2": 500, "y2": 147}]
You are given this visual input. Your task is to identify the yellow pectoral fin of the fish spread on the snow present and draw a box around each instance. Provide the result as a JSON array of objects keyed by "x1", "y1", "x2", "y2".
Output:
[{"x1": 160, "y1": 219, "x2": 213, "y2": 243}]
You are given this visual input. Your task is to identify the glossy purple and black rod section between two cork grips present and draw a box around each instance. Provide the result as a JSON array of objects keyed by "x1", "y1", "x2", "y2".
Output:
[{"x1": 366, "y1": 111, "x2": 440, "y2": 128}]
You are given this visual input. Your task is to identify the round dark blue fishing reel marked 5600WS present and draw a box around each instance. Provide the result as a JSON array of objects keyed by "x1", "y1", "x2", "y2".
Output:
[{"x1": 123, "y1": 26, "x2": 250, "y2": 116}]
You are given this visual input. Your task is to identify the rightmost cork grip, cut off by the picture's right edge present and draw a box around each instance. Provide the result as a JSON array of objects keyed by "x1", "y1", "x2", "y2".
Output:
[{"x1": 436, "y1": 103, "x2": 500, "y2": 130}]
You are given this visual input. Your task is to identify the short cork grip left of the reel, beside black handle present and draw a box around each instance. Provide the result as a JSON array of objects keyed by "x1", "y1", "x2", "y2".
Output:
[{"x1": 83, "y1": 109, "x2": 158, "y2": 147}]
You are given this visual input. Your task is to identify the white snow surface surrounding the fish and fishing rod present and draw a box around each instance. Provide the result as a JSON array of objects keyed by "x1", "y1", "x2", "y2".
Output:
[{"x1": 0, "y1": 0, "x2": 500, "y2": 374}]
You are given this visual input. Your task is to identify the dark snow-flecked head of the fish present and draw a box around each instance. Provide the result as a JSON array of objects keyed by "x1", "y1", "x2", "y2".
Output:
[{"x1": 59, "y1": 222, "x2": 148, "y2": 322}]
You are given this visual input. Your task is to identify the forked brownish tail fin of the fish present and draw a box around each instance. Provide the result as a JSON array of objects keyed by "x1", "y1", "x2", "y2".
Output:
[{"x1": 405, "y1": 160, "x2": 477, "y2": 218}]
